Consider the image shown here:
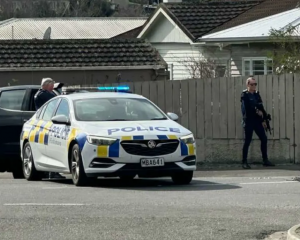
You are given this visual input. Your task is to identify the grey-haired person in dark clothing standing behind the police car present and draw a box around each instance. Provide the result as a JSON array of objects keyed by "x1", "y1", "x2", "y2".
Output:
[{"x1": 34, "y1": 78, "x2": 65, "y2": 179}]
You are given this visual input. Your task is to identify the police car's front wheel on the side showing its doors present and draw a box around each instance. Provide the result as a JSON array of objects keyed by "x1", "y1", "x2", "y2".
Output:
[{"x1": 71, "y1": 144, "x2": 88, "y2": 186}]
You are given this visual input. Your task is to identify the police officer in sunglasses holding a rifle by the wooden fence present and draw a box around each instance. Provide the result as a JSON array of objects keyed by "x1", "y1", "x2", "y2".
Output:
[{"x1": 241, "y1": 76, "x2": 275, "y2": 169}]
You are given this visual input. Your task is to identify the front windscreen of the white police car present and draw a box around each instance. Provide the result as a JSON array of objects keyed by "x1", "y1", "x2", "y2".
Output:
[{"x1": 74, "y1": 98, "x2": 167, "y2": 121}]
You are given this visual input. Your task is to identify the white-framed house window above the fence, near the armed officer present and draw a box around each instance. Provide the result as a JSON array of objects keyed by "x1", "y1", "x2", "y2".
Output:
[{"x1": 243, "y1": 57, "x2": 273, "y2": 76}]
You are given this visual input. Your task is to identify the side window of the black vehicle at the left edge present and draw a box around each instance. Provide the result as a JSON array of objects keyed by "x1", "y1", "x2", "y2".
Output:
[{"x1": 0, "y1": 89, "x2": 26, "y2": 110}]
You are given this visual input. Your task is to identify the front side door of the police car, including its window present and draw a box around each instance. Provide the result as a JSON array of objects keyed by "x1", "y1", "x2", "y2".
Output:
[{"x1": 46, "y1": 98, "x2": 70, "y2": 170}]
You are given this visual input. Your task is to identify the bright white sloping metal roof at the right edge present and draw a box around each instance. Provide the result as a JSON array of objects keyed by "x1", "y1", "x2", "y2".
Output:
[{"x1": 200, "y1": 8, "x2": 300, "y2": 41}]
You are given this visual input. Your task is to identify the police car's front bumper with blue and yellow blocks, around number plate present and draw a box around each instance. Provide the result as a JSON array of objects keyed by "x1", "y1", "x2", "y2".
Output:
[{"x1": 81, "y1": 136, "x2": 197, "y2": 177}]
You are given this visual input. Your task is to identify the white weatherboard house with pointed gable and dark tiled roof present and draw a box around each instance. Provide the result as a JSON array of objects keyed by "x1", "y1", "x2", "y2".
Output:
[{"x1": 138, "y1": 0, "x2": 298, "y2": 80}]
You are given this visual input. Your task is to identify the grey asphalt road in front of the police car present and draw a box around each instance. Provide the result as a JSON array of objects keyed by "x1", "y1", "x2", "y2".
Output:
[{"x1": 0, "y1": 167, "x2": 300, "y2": 240}]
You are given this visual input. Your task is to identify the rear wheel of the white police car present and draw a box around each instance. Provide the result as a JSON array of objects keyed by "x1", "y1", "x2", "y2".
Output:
[{"x1": 22, "y1": 142, "x2": 42, "y2": 181}]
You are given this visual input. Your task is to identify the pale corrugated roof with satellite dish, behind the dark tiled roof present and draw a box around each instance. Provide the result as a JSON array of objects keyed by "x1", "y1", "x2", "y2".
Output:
[{"x1": 0, "y1": 17, "x2": 147, "y2": 40}]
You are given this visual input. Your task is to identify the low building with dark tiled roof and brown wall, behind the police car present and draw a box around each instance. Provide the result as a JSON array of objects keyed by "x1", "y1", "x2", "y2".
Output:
[{"x1": 0, "y1": 39, "x2": 168, "y2": 86}]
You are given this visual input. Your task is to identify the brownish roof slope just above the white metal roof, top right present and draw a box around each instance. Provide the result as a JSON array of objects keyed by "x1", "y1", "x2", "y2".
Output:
[{"x1": 210, "y1": 0, "x2": 299, "y2": 33}]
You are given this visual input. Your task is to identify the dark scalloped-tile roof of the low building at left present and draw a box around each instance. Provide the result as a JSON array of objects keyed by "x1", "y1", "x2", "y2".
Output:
[{"x1": 0, "y1": 39, "x2": 166, "y2": 71}]
